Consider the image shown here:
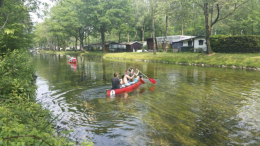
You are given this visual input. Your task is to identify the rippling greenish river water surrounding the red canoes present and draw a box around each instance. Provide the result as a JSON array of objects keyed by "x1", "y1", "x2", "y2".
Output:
[{"x1": 33, "y1": 54, "x2": 260, "y2": 146}]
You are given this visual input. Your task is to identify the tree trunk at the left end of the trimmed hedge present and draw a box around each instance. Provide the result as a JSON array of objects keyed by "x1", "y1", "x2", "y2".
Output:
[{"x1": 204, "y1": 2, "x2": 213, "y2": 54}]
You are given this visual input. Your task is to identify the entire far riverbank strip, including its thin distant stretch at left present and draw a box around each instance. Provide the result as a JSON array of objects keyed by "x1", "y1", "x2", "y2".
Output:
[{"x1": 40, "y1": 51, "x2": 260, "y2": 71}]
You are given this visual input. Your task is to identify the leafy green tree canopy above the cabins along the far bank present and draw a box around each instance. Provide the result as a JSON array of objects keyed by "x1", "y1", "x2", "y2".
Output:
[{"x1": 35, "y1": 0, "x2": 260, "y2": 52}]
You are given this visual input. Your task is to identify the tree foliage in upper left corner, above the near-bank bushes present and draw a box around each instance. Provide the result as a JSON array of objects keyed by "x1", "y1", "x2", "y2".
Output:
[{"x1": 0, "y1": 0, "x2": 37, "y2": 53}]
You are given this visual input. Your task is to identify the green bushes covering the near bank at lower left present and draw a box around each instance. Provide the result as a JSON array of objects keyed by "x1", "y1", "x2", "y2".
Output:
[{"x1": 0, "y1": 50, "x2": 92, "y2": 146}]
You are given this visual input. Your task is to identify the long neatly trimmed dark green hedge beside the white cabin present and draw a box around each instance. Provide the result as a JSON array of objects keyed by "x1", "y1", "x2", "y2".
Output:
[{"x1": 210, "y1": 36, "x2": 260, "y2": 53}]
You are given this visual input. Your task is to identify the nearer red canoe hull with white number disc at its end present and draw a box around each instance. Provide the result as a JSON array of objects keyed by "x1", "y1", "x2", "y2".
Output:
[{"x1": 107, "y1": 80, "x2": 141, "y2": 96}]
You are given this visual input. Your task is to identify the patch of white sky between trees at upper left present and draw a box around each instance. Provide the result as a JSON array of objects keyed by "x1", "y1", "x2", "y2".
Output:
[{"x1": 30, "y1": 0, "x2": 55, "y2": 23}]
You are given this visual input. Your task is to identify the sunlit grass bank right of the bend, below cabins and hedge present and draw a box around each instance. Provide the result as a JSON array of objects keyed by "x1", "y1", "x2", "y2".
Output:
[{"x1": 104, "y1": 52, "x2": 260, "y2": 67}]
